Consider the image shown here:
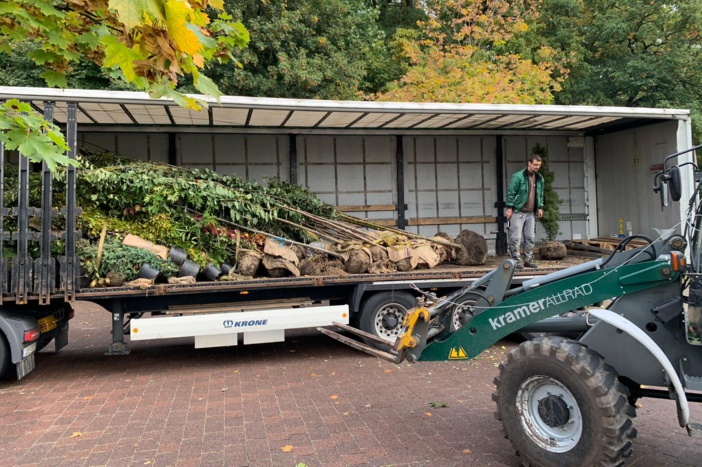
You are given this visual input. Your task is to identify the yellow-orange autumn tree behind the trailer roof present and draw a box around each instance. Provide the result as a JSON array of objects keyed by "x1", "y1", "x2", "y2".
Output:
[{"x1": 371, "y1": 0, "x2": 565, "y2": 104}]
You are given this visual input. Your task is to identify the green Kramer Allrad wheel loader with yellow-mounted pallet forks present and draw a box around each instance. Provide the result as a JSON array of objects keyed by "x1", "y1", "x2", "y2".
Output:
[{"x1": 320, "y1": 146, "x2": 702, "y2": 466}]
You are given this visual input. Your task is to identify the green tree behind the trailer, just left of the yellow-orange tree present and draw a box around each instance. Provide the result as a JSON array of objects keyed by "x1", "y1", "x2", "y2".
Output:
[{"x1": 212, "y1": 0, "x2": 388, "y2": 99}]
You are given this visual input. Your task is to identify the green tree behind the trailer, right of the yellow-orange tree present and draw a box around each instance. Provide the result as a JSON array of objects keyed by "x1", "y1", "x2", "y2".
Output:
[{"x1": 539, "y1": 0, "x2": 702, "y2": 144}]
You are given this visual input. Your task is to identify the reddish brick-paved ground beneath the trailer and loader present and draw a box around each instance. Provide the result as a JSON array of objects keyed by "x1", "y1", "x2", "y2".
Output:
[{"x1": 0, "y1": 308, "x2": 702, "y2": 467}]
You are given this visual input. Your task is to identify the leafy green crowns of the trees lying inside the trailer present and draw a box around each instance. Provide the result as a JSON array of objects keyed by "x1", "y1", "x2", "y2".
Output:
[{"x1": 78, "y1": 153, "x2": 334, "y2": 262}]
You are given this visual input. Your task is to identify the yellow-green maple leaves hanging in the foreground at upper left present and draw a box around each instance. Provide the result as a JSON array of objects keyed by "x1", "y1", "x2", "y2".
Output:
[{"x1": 0, "y1": 0, "x2": 249, "y2": 167}]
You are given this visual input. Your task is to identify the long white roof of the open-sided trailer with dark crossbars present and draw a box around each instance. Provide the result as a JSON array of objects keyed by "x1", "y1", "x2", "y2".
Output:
[{"x1": 0, "y1": 86, "x2": 690, "y2": 134}]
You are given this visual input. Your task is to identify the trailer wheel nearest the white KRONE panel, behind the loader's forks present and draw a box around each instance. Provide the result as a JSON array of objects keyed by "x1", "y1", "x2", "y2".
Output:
[{"x1": 359, "y1": 292, "x2": 417, "y2": 347}]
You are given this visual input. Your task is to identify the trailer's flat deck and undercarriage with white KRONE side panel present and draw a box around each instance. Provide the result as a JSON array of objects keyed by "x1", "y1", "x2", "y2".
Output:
[{"x1": 0, "y1": 252, "x2": 556, "y2": 379}]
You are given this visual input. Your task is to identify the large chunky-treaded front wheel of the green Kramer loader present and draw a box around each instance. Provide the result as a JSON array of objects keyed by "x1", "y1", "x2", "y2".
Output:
[{"x1": 492, "y1": 337, "x2": 636, "y2": 467}]
